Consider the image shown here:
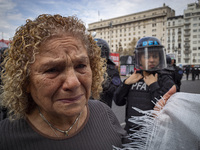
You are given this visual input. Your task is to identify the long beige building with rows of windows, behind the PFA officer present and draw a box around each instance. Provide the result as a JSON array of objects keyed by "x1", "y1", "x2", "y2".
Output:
[{"x1": 88, "y1": 4, "x2": 175, "y2": 52}]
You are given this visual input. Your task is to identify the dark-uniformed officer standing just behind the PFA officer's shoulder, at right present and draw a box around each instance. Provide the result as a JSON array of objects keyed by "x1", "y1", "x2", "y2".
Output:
[{"x1": 171, "y1": 57, "x2": 183, "y2": 92}]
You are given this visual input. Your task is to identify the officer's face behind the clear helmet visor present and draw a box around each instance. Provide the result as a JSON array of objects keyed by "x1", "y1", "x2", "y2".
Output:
[{"x1": 140, "y1": 52, "x2": 160, "y2": 70}]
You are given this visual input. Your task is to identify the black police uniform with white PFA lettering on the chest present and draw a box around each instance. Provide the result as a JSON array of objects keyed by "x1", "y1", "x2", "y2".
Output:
[{"x1": 114, "y1": 74, "x2": 174, "y2": 133}]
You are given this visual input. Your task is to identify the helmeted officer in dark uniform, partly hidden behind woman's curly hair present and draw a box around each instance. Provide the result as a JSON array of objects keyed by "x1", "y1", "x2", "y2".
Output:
[{"x1": 94, "y1": 38, "x2": 121, "y2": 107}]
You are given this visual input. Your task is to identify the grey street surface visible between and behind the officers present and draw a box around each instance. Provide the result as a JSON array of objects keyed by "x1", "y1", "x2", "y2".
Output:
[{"x1": 112, "y1": 74, "x2": 200, "y2": 126}]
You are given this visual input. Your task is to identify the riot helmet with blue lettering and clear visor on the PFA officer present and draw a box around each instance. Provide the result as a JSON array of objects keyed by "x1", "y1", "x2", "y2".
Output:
[{"x1": 135, "y1": 37, "x2": 166, "y2": 71}]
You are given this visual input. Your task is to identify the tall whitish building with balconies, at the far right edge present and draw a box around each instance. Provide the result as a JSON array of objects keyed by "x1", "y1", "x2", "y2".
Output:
[{"x1": 184, "y1": 1, "x2": 200, "y2": 65}]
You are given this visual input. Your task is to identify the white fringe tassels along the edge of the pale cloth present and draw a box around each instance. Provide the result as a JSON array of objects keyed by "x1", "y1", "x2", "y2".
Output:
[{"x1": 113, "y1": 97, "x2": 164, "y2": 150}]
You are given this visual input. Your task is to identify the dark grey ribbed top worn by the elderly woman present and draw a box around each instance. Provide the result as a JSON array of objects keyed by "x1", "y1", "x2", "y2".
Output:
[{"x1": 0, "y1": 100, "x2": 126, "y2": 150}]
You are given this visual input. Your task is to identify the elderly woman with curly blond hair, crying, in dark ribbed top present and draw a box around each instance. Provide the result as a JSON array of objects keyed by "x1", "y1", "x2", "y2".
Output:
[{"x1": 0, "y1": 14, "x2": 126, "y2": 150}]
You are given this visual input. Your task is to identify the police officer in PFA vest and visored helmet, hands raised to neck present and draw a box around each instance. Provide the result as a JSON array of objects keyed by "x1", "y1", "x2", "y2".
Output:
[{"x1": 114, "y1": 37, "x2": 175, "y2": 134}]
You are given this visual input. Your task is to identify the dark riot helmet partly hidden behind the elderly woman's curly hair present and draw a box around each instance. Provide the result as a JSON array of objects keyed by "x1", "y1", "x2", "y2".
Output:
[{"x1": 94, "y1": 38, "x2": 110, "y2": 60}]
